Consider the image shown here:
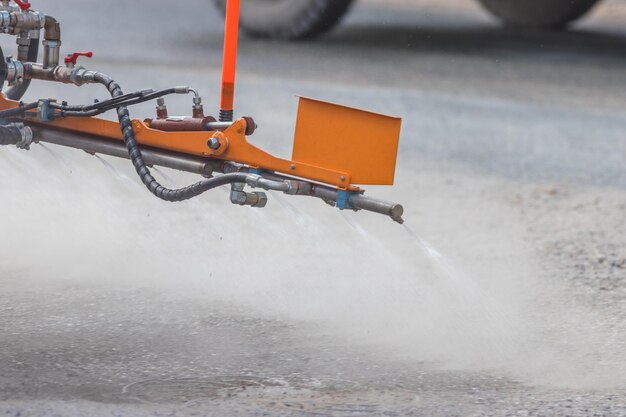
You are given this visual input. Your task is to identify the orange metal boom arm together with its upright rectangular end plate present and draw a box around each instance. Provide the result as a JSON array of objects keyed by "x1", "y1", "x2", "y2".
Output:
[{"x1": 0, "y1": 97, "x2": 400, "y2": 190}]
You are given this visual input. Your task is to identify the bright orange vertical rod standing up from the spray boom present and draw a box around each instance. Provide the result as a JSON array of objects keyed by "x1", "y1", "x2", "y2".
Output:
[{"x1": 220, "y1": 0, "x2": 241, "y2": 122}]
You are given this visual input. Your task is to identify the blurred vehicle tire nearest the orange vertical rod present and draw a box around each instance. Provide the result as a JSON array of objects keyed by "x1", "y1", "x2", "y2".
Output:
[{"x1": 213, "y1": 0, "x2": 353, "y2": 39}]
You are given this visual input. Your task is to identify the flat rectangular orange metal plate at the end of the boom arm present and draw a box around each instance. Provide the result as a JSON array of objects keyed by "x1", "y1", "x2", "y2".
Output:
[{"x1": 292, "y1": 97, "x2": 402, "y2": 185}]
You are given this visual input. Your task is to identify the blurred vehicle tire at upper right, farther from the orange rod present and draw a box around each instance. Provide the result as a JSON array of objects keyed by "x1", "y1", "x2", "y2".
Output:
[{"x1": 478, "y1": 0, "x2": 600, "y2": 28}]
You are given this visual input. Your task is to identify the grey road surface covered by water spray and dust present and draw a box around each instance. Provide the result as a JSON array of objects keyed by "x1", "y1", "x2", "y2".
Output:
[{"x1": 0, "y1": 0, "x2": 626, "y2": 417}]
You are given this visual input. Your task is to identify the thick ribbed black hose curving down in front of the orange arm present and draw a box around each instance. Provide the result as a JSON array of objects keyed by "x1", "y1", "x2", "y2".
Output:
[{"x1": 94, "y1": 73, "x2": 248, "y2": 202}]
